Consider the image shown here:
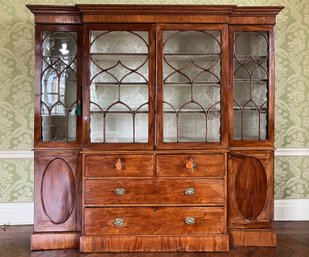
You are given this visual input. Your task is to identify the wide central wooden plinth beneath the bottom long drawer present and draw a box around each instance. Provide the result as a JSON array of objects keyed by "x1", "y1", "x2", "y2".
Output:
[{"x1": 80, "y1": 234, "x2": 229, "y2": 253}]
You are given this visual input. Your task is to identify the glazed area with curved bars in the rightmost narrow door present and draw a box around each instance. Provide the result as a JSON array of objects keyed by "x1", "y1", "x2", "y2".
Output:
[{"x1": 234, "y1": 31, "x2": 269, "y2": 140}]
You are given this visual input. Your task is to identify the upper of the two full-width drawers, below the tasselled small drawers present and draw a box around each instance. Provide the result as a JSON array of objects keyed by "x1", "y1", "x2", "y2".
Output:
[{"x1": 84, "y1": 178, "x2": 224, "y2": 205}]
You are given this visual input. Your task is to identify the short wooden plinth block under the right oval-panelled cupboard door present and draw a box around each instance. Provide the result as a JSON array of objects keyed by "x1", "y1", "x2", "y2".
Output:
[{"x1": 229, "y1": 229, "x2": 277, "y2": 247}]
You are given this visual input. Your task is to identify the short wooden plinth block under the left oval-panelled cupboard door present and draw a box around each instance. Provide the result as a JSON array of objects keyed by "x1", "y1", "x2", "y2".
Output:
[{"x1": 31, "y1": 232, "x2": 81, "y2": 250}]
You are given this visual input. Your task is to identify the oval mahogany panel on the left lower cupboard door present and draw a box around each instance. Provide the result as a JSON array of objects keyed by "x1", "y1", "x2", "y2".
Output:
[{"x1": 41, "y1": 158, "x2": 75, "y2": 224}]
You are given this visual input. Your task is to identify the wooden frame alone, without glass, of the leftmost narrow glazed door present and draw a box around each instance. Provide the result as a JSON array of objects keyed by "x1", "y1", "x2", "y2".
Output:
[{"x1": 34, "y1": 24, "x2": 83, "y2": 149}]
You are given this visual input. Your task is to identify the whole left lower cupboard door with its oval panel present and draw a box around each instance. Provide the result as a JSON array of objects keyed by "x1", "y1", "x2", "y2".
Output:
[{"x1": 34, "y1": 151, "x2": 81, "y2": 232}]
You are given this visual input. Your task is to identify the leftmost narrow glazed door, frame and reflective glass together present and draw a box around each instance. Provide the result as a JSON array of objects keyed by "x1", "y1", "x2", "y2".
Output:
[{"x1": 34, "y1": 25, "x2": 82, "y2": 148}]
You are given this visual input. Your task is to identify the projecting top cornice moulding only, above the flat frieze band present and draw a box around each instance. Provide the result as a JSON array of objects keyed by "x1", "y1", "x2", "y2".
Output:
[{"x1": 26, "y1": 4, "x2": 284, "y2": 16}]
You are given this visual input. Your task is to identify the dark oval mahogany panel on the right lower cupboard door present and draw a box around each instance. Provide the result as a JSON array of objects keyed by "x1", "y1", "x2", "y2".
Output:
[{"x1": 235, "y1": 157, "x2": 267, "y2": 221}]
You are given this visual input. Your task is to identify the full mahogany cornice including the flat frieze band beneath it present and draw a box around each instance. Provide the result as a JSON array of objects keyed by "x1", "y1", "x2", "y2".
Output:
[{"x1": 27, "y1": 4, "x2": 283, "y2": 25}]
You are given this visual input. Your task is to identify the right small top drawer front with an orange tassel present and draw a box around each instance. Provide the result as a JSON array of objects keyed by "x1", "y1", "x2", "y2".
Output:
[{"x1": 156, "y1": 154, "x2": 225, "y2": 177}]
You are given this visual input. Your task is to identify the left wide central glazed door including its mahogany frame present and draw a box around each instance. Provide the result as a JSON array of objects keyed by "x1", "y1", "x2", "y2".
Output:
[{"x1": 84, "y1": 24, "x2": 155, "y2": 149}]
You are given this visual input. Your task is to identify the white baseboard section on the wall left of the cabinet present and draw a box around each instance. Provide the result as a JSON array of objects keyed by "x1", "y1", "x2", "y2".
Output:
[{"x1": 0, "y1": 203, "x2": 34, "y2": 225}]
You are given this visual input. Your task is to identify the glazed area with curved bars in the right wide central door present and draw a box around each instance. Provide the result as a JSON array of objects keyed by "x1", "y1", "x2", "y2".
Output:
[{"x1": 163, "y1": 31, "x2": 222, "y2": 142}]
